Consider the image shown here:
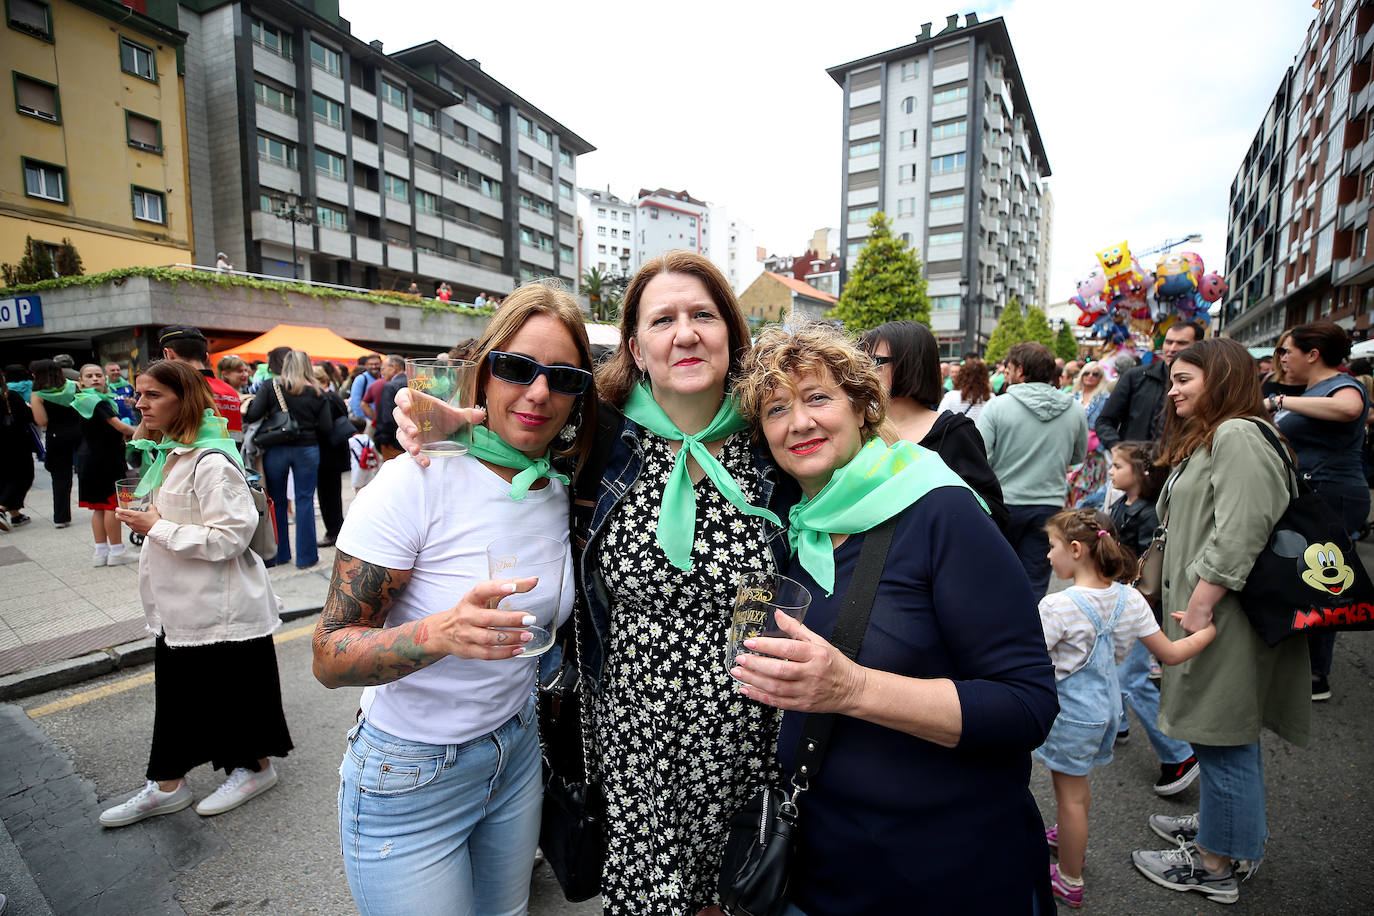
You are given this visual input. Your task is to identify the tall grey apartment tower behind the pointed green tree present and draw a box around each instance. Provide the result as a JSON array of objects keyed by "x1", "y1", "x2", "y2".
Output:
[{"x1": 827, "y1": 14, "x2": 1050, "y2": 357}]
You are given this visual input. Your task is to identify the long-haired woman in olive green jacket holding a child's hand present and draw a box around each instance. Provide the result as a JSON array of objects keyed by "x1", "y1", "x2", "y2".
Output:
[{"x1": 1132, "y1": 338, "x2": 1312, "y2": 904}]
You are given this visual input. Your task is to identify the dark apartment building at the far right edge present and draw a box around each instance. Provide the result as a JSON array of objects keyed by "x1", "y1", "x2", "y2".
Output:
[{"x1": 1247, "y1": 0, "x2": 1374, "y2": 345}]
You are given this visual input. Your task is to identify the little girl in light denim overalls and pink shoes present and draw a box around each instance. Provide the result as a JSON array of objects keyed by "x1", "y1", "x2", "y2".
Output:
[{"x1": 1033, "y1": 509, "x2": 1216, "y2": 906}]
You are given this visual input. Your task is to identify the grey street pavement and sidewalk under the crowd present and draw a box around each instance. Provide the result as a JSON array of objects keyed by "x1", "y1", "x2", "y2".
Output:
[{"x1": 0, "y1": 466, "x2": 1374, "y2": 916}]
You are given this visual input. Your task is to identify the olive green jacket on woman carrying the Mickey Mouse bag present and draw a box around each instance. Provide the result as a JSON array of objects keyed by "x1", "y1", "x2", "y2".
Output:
[{"x1": 1158, "y1": 419, "x2": 1312, "y2": 747}]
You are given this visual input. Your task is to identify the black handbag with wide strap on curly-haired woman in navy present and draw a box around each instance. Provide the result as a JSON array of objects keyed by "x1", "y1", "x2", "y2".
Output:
[{"x1": 719, "y1": 516, "x2": 897, "y2": 916}]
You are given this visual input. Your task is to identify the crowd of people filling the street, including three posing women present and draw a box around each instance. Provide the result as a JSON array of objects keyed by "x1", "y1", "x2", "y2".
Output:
[{"x1": 0, "y1": 251, "x2": 1374, "y2": 916}]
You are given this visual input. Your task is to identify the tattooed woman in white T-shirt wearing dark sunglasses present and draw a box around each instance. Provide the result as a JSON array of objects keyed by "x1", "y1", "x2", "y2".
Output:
[{"x1": 315, "y1": 283, "x2": 596, "y2": 916}]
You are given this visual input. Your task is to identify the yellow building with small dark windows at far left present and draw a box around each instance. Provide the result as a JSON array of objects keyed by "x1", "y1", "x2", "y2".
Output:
[{"x1": 0, "y1": 0, "x2": 193, "y2": 273}]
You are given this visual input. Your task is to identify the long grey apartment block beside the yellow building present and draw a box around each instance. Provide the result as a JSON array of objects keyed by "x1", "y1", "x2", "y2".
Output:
[{"x1": 179, "y1": 0, "x2": 594, "y2": 301}]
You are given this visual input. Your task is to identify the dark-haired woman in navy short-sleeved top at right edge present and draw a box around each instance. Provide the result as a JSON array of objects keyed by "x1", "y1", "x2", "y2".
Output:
[{"x1": 1264, "y1": 321, "x2": 1370, "y2": 700}]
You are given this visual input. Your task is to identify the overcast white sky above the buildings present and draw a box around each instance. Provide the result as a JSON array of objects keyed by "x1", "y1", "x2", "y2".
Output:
[{"x1": 339, "y1": 0, "x2": 1316, "y2": 302}]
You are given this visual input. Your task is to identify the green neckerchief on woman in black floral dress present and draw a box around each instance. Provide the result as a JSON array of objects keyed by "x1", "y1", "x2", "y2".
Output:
[{"x1": 625, "y1": 383, "x2": 782, "y2": 570}]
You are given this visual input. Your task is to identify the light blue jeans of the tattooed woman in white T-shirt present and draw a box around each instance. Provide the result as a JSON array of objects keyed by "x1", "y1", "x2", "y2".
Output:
[{"x1": 338, "y1": 695, "x2": 544, "y2": 916}]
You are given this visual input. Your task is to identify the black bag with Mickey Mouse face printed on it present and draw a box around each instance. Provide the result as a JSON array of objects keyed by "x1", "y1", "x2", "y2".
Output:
[{"x1": 1241, "y1": 420, "x2": 1374, "y2": 645}]
